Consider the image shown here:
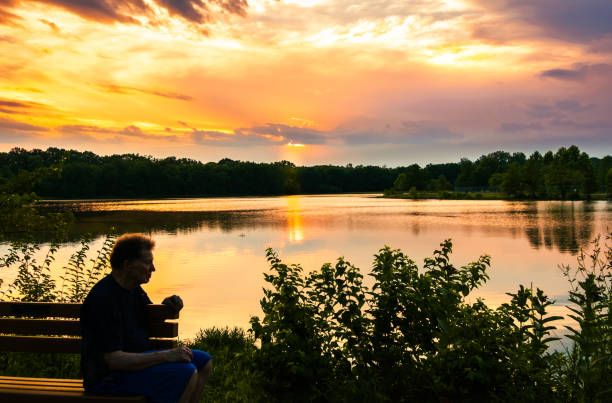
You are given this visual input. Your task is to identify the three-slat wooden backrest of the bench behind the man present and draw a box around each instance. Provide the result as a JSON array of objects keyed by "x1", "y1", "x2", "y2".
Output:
[{"x1": 0, "y1": 302, "x2": 178, "y2": 353}]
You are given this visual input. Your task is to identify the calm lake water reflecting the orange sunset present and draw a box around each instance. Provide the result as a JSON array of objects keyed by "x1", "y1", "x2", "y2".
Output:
[{"x1": 4, "y1": 195, "x2": 612, "y2": 338}]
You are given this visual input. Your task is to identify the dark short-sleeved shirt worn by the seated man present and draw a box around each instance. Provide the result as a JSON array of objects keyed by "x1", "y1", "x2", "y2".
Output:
[{"x1": 81, "y1": 274, "x2": 152, "y2": 389}]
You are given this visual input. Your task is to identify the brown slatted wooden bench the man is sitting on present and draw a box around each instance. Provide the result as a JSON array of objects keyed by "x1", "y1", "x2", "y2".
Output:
[{"x1": 0, "y1": 302, "x2": 178, "y2": 403}]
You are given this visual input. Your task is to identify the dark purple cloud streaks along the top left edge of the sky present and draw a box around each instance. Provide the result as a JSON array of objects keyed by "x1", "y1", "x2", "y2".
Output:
[{"x1": 0, "y1": 0, "x2": 249, "y2": 24}]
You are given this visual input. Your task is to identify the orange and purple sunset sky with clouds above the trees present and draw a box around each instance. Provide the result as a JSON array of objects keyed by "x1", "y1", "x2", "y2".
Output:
[{"x1": 0, "y1": 0, "x2": 612, "y2": 166}]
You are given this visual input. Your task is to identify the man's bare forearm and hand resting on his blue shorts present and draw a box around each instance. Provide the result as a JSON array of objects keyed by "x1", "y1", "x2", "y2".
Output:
[{"x1": 104, "y1": 347, "x2": 193, "y2": 371}]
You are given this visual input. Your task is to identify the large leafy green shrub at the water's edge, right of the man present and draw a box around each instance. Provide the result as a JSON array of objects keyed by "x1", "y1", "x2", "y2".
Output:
[{"x1": 251, "y1": 240, "x2": 558, "y2": 401}]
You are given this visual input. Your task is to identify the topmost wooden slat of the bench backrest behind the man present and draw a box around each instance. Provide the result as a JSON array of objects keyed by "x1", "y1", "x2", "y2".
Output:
[{"x1": 0, "y1": 301, "x2": 179, "y2": 321}]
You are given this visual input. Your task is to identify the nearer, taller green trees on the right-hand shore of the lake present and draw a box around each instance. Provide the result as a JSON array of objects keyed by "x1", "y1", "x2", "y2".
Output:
[{"x1": 390, "y1": 145, "x2": 612, "y2": 200}]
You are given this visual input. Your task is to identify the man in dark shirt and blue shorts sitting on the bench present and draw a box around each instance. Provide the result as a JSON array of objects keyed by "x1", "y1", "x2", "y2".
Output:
[{"x1": 81, "y1": 234, "x2": 212, "y2": 403}]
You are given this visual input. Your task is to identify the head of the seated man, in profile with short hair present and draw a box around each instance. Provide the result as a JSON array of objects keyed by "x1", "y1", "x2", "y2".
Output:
[{"x1": 110, "y1": 234, "x2": 155, "y2": 286}]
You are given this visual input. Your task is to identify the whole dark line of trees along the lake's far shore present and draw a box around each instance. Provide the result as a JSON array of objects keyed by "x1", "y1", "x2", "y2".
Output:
[{"x1": 0, "y1": 146, "x2": 612, "y2": 198}]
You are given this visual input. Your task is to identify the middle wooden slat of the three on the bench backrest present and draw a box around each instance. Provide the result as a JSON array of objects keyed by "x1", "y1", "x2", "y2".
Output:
[{"x1": 0, "y1": 318, "x2": 178, "y2": 338}]
